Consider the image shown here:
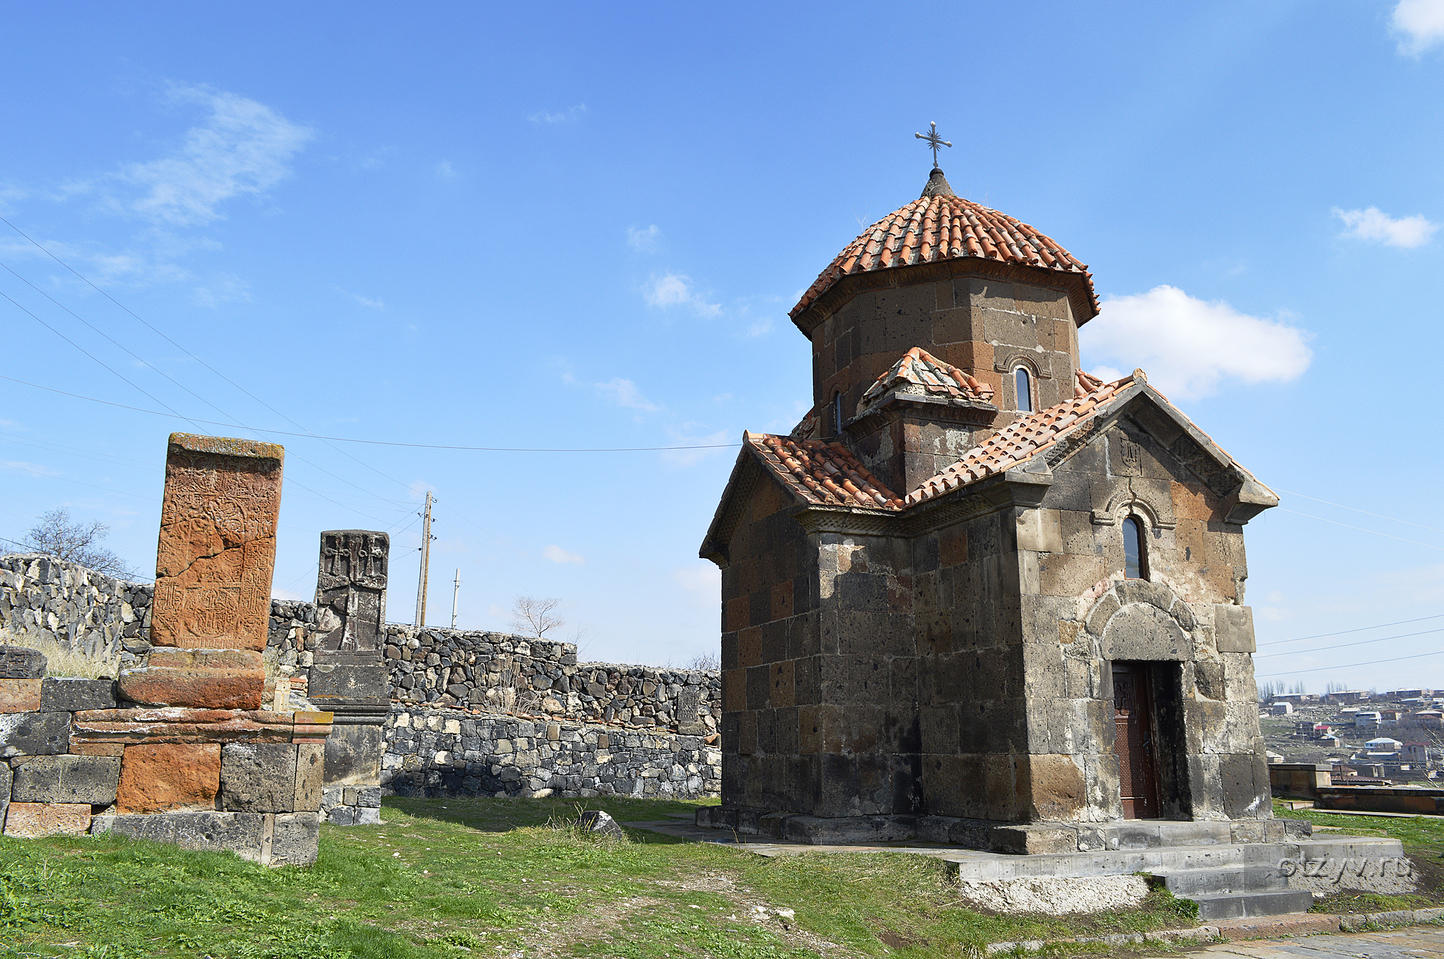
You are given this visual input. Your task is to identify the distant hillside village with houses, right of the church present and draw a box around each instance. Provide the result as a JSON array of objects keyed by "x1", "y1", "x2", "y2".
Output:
[{"x1": 1259, "y1": 689, "x2": 1444, "y2": 786}]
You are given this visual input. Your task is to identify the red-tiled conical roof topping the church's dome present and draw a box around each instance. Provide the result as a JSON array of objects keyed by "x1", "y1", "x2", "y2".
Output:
[{"x1": 790, "y1": 168, "x2": 1099, "y2": 325}]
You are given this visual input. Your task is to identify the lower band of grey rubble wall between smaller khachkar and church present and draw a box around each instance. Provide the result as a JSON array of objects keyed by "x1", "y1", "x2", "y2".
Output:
[{"x1": 381, "y1": 705, "x2": 722, "y2": 799}]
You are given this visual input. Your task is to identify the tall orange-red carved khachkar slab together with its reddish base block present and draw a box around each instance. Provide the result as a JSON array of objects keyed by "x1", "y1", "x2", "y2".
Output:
[{"x1": 120, "y1": 433, "x2": 284, "y2": 709}]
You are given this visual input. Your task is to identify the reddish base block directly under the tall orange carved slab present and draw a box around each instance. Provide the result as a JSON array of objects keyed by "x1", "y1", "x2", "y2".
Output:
[{"x1": 117, "y1": 646, "x2": 266, "y2": 709}]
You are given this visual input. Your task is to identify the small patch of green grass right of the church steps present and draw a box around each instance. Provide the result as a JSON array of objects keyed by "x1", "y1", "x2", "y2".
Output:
[{"x1": 1274, "y1": 800, "x2": 1444, "y2": 913}]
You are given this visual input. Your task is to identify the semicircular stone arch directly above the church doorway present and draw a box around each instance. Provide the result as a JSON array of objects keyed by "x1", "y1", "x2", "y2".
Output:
[{"x1": 1083, "y1": 579, "x2": 1199, "y2": 661}]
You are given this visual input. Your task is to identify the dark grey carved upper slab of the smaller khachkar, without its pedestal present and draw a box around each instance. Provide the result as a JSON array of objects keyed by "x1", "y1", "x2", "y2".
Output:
[{"x1": 315, "y1": 530, "x2": 391, "y2": 661}]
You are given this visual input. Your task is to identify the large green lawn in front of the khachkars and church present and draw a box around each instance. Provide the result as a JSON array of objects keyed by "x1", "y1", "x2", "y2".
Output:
[{"x1": 0, "y1": 799, "x2": 1191, "y2": 959}]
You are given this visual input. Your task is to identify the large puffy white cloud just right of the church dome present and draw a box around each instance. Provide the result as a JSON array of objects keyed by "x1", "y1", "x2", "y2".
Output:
[{"x1": 1083, "y1": 286, "x2": 1313, "y2": 400}]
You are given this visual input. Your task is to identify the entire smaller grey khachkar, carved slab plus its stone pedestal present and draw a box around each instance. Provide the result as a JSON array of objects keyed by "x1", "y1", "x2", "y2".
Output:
[{"x1": 308, "y1": 530, "x2": 391, "y2": 825}]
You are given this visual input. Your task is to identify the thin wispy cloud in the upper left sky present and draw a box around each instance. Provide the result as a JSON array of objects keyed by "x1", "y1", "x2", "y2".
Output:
[{"x1": 113, "y1": 87, "x2": 313, "y2": 225}]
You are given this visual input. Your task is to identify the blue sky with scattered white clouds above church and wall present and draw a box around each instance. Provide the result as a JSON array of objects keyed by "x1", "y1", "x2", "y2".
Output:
[{"x1": 0, "y1": 0, "x2": 1444, "y2": 690}]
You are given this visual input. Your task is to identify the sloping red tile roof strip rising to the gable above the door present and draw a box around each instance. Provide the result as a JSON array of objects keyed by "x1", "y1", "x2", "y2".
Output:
[{"x1": 907, "y1": 370, "x2": 1136, "y2": 505}]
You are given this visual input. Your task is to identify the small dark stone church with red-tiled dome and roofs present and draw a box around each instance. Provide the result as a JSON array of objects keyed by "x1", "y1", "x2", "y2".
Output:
[{"x1": 699, "y1": 166, "x2": 1282, "y2": 851}]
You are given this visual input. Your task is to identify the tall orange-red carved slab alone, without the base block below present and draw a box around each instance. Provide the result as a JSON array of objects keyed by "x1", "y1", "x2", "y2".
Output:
[{"x1": 150, "y1": 433, "x2": 284, "y2": 653}]
